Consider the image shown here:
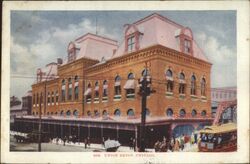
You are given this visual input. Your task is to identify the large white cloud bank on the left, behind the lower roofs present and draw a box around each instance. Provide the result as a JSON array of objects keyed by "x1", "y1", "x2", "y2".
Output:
[{"x1": 11, "y1": 16, "x2": 117, "y2": 97}]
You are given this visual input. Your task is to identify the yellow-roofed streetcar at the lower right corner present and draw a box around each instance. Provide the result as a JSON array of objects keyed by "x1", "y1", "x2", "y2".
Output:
[{"x1": 198, "y1": 123, "x2": 237, "y2": 152}]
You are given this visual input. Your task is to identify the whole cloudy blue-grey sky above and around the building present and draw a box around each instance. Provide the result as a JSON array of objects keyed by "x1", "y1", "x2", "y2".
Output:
[{"x1": 10, "y1": 10, "x2": 237, "y2": 98}]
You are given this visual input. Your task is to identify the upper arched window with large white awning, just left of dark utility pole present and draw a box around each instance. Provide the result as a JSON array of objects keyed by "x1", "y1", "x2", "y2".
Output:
[{"x1": 124, "y1": 73, "x2": 135, "y2": 98}]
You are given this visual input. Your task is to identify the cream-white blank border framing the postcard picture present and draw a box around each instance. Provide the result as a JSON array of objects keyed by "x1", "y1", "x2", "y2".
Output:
[{"x1": 1, "y1": 1, "x2": 249, "y2": 163}]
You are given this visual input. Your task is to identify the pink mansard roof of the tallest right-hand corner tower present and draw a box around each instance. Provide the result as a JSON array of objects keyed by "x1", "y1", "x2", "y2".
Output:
[{"x1": 113, "y1": 13, "x2": 208, "y2": 61}]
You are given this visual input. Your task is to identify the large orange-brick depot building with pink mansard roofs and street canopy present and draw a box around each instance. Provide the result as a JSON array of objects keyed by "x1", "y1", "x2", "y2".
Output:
[{"x1": 15, "y1": 13, "x2": 212, "y2": 147}]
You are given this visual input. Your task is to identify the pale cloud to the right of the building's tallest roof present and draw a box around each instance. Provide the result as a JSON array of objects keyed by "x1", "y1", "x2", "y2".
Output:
[{"x1": 196, "y1": 32, "x2": 237, "y2": 87}]
